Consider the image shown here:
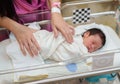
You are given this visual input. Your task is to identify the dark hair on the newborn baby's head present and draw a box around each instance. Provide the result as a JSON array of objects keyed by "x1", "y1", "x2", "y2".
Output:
[{"x1": 86, "y1": 28, "x2": 106, "y2": 46}]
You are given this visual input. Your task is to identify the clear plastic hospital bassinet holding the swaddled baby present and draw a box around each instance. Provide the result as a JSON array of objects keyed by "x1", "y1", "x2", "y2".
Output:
[{"x1": 0, "y1": 0, "x2": 120, "y2": 84}]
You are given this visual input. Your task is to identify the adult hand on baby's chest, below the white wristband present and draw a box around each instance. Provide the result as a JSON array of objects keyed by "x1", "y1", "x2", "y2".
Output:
[{"x1": 51, "y1": 12, "x2": 74, "y2": 43}]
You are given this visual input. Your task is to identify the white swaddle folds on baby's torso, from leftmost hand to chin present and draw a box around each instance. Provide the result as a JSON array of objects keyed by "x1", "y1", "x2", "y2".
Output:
[{"x1": 34, "y1": 30, "x2": 88, "y2": 61}]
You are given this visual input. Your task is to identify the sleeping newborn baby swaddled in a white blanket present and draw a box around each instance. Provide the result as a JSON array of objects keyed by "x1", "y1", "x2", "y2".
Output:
[{"x1": 6, "y1": 28, "x2": 106, "y2": 61}]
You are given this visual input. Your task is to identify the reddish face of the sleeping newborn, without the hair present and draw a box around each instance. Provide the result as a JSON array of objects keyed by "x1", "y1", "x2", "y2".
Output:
[{"x1": 83, "y1": 34, "x2": 102, "y2": 52}]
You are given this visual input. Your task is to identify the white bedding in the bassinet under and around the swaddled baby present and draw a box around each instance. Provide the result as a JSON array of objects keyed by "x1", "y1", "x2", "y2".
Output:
[{"x1": 0, "y1": 23, "x2": 120, "y2": 84}]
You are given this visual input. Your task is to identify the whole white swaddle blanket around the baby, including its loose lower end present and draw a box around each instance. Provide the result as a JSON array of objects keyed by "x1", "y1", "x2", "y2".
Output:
[{"x1": 6, "y1": 23, "x2": 88, "y2": 68}]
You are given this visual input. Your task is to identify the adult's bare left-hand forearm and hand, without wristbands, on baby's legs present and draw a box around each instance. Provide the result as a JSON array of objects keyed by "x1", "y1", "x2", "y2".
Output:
[{"x1": 0, "y1": 17, "x2": 40, "y2": 56}]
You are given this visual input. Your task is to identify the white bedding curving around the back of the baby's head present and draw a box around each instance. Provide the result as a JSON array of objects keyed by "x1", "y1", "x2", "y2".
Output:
[{"x1": 76, "y1": 23, "x2": 120, "y2": 52}]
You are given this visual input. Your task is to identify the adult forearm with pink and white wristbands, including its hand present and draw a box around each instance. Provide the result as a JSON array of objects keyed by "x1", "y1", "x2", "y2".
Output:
[{"x1": 49, "y1": 0, "x2": 74, "y2": 43}]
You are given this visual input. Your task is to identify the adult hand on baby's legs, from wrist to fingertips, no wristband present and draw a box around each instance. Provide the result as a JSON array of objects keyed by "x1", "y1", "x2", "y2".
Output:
[{"x1": 14, "y1": 25, "x2": 40, "y2": 56}]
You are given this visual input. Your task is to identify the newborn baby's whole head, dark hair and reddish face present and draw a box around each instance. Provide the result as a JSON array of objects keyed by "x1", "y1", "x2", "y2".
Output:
[{"x1": 83, "y1": 28, "x2": 106, "y2": 52}]
